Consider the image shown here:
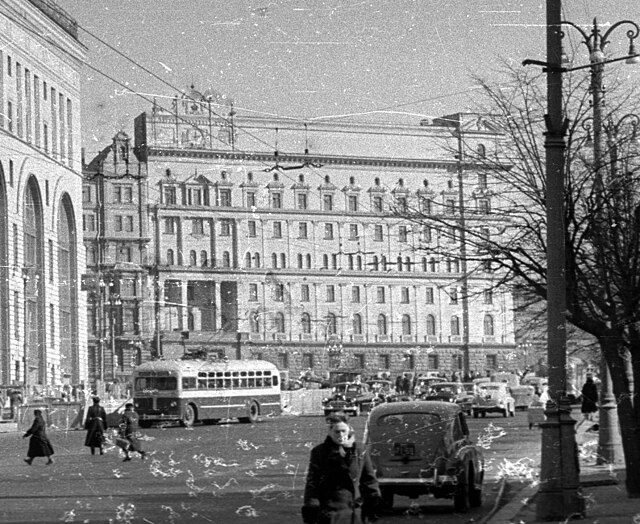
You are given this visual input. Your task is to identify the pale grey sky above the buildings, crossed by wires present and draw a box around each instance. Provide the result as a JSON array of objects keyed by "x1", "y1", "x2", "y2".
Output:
[{"x1": 56, "y1": 0, "x2": 640, "y2": 159}]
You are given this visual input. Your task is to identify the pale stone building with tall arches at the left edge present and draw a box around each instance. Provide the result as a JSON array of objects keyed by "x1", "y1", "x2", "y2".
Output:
[{"x1": 0, "y1": 0, "x2": 87, "y2": 393}]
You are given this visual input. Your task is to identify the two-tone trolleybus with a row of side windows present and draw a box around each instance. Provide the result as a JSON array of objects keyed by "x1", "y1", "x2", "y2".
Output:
[{"x1": 133, "y1": 359, "x2": 281, "y2": 427}]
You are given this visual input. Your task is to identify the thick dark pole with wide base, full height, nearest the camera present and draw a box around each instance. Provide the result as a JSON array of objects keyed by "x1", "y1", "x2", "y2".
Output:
[{"x1": 536, "y1": 0, "x2": 585, "y2": 521}]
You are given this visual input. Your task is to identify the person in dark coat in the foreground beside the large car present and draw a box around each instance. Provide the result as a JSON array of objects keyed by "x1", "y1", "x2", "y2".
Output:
[{"x1": 302, "y1": 414, "x2": 381, "y2": 524}]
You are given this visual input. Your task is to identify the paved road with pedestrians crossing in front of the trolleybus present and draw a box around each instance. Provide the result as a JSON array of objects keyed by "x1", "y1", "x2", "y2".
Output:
[{"x1": 0, "y1": 413, "x2": 539, "y2": 524}]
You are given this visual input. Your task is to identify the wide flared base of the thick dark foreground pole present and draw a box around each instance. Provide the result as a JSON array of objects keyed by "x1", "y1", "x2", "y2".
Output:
[{"x1": 536, "y1": 400, "x2": 585, "y2": 521}]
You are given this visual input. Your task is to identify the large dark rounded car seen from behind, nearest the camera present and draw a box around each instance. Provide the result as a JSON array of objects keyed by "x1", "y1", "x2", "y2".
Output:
[{"x1": 365, "y1": 400, "x2": 484, "y2": 512}]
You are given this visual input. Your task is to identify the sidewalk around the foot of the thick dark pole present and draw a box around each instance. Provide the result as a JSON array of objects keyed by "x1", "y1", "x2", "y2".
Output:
[{"x1": 487, "y1": 420, "x2": 640, "y2": 524}]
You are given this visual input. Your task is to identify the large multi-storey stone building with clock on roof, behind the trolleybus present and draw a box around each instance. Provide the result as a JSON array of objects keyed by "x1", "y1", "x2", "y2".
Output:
[{"x1": 85, "y1": 90, "x2": 515, "y2": 384}]
